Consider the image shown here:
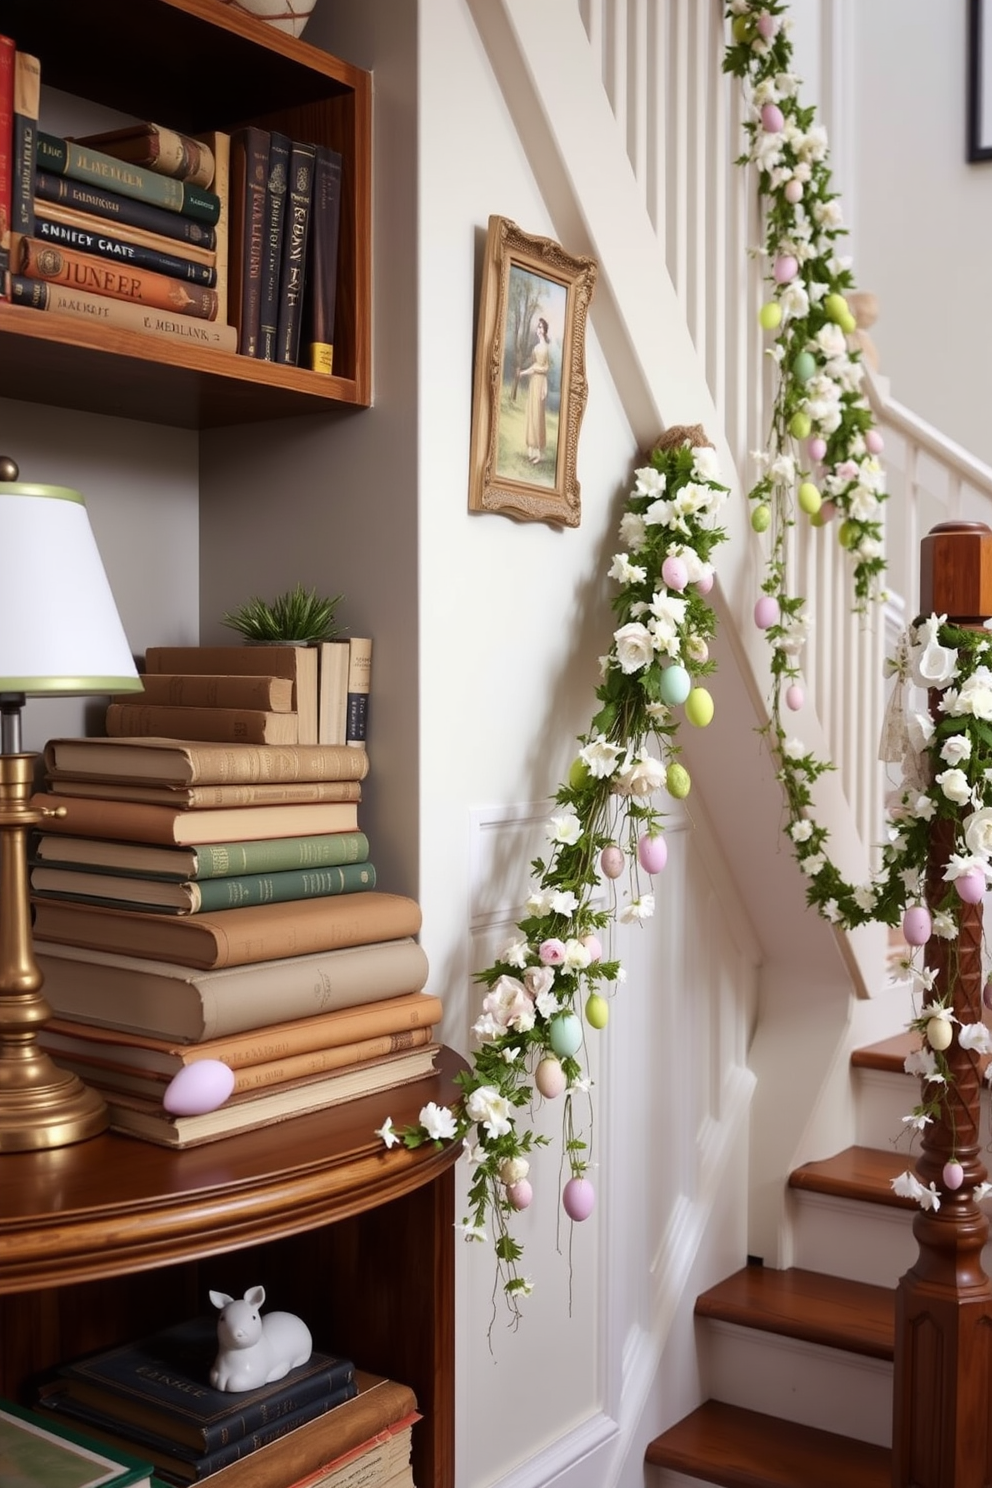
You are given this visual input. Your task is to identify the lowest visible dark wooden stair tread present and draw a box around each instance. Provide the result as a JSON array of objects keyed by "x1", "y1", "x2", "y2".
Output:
[{"x1": 644, "y1": 1400, "x2": 892, "y2": 1488}]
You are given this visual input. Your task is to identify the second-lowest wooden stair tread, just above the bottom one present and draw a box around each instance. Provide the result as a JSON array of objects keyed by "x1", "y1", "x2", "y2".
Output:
[{"x1": 696, "y1": 1266, "x2": 895, "y2": 1360}]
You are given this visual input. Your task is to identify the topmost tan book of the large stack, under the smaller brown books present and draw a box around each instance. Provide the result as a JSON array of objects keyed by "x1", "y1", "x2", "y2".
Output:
[{"x1": 45, "y1": 735, "x2": 369, "y2": 786}]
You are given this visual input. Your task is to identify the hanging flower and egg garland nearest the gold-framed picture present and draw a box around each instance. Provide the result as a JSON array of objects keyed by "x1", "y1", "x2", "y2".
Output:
[{"x1": 376, "y1": 429, "x2": 729, "y2": 1323}]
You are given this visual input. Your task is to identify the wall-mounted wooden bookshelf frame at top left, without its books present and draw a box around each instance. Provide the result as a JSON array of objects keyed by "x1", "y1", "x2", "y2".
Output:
[{"x1": 0, "y1": 0, "x2": 372, "y2": 429}]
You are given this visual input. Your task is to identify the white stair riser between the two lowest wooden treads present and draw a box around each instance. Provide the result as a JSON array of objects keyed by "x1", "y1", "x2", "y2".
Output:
[{"x1": 698, "y1": 1318, "x2": 892, "y2": 1446}]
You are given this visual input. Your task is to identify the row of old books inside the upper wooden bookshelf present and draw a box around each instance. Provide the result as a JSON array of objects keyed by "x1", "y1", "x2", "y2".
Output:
[{"x1": 0, "y1": 36, "x2": 342, "y2": 373}]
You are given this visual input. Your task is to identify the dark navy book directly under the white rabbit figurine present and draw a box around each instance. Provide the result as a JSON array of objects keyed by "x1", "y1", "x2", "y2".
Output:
[{"x1": 47, "y1": 1312, "x2": 354, "y2": 1457}]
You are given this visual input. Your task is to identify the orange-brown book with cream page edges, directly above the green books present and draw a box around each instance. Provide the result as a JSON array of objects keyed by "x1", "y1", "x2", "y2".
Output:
[{"x1": 33, "y1": 792, "x2": 358, "y2": 845}]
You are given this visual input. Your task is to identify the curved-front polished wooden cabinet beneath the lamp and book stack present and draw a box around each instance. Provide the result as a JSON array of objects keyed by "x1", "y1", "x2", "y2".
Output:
[{"x1": 0, "y1": 1051, "x2": 464, "y2": 1488}]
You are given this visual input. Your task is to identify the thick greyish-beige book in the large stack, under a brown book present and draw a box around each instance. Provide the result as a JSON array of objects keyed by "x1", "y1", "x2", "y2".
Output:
[{"x1": 36, "y1": 936, "x2": 428, "y2": 1058}]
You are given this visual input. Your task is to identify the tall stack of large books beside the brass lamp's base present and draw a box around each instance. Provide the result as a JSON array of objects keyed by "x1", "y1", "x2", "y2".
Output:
[{"x1": 31, "y1": 737, "x2": 442, "y2": 1147}]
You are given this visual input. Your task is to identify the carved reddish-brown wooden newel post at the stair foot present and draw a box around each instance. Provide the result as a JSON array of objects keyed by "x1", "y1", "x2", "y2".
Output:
[{"x1": 892, "y1": 522, "x2": 992, "y2": 1488}]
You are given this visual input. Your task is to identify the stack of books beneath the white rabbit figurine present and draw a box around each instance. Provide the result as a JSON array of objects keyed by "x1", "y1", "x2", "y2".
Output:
[{"x1": 37, "y1": 1314, "x2": 419, "y2": 1488}]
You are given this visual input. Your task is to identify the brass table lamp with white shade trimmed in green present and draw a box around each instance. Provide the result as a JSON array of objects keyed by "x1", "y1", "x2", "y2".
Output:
[{"x1": 0, "y1": 457, "x2": 141, "y2": 1155}]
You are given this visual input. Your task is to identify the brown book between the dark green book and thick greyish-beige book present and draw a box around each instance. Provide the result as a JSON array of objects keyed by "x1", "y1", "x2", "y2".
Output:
[{"x1": 33, "y1": 888, "x2": 421, "y2": 969}]
